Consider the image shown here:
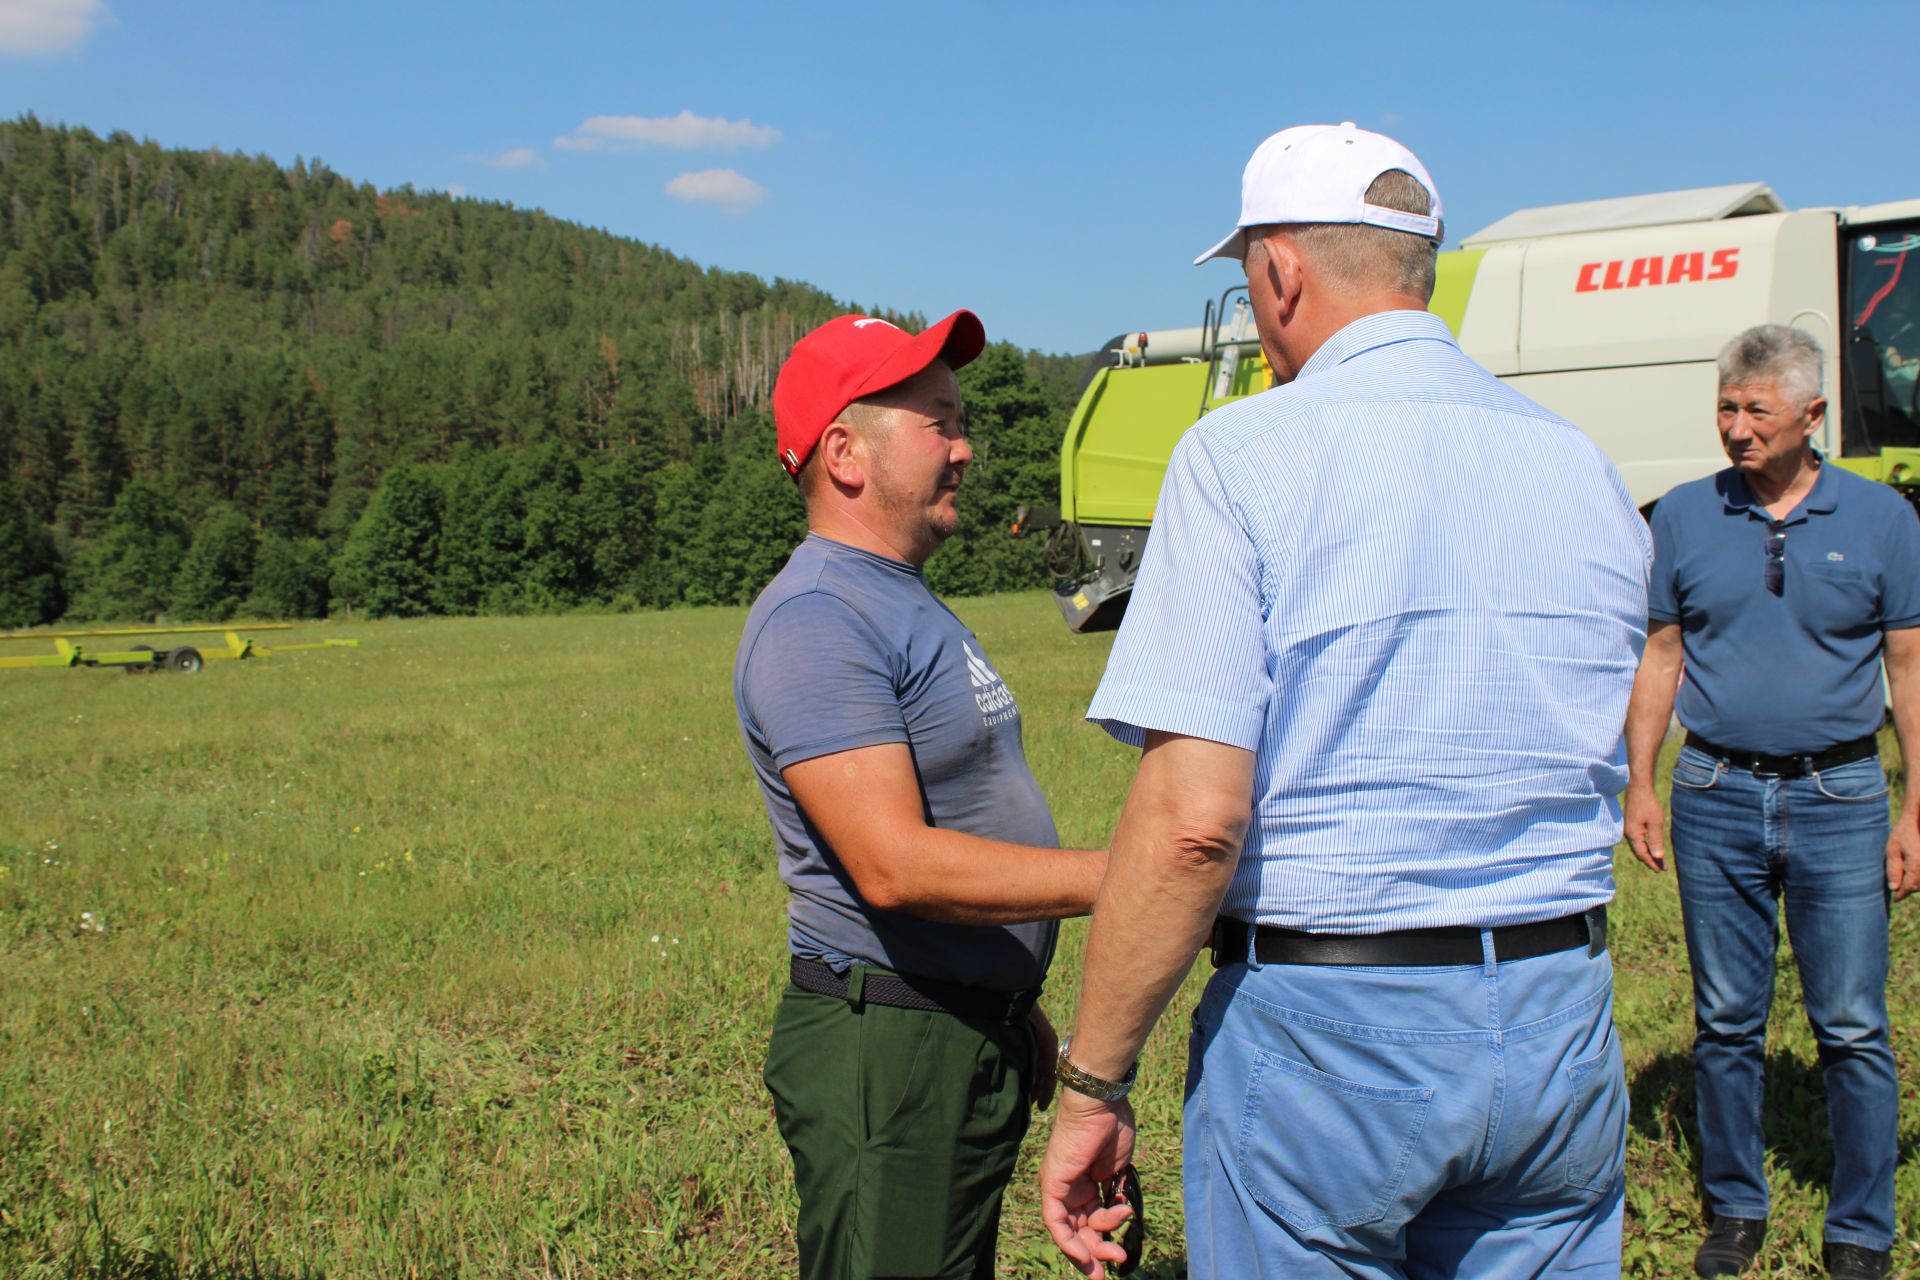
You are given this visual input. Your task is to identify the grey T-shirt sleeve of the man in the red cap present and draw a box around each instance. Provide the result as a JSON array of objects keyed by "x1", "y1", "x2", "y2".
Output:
[{"x1": 741, "y1": 591, "x2": 908, "y2": 770}]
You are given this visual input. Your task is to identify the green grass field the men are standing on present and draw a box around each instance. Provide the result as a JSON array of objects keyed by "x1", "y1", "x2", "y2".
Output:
[{"x1": 0, "y1": 595, "x2": 1920, "y2": 1280}]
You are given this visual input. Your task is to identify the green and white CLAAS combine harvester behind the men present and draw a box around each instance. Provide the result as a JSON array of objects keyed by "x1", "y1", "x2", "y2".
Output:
[{"x1": 1014, "y1": 184, "x2": 1920, "y2": 631}]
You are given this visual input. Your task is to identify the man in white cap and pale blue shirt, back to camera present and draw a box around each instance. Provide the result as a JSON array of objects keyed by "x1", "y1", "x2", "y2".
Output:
[{"x1": 1041, "y1": 125, "x2": 1651, "y2": 1278}]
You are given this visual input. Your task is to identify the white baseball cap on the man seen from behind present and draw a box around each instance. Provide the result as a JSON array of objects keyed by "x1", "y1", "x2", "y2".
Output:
[{"x1": 1194, "y1": 121, "x2": 1440, "y2": 267}]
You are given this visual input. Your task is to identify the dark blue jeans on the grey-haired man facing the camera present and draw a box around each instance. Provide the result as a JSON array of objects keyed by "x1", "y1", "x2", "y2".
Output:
[{"x1": 1672, "y1": 747, "x2": 1899, "y2": 1249}]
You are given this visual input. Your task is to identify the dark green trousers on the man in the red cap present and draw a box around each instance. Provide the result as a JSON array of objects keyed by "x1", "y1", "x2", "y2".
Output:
[{"x1": 766, "y1": 974, "x2": 1035, "y2": 1280}]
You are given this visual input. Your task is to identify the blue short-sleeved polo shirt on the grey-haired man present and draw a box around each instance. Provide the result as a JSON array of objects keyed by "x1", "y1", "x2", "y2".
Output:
[{"x1": 1647, "y1": 464, "x2": 1920, "y2": 756}]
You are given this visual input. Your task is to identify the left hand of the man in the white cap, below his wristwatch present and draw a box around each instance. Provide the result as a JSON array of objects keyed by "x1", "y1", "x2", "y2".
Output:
[{"x1": 1041, "y1": 1090, "x2": 1133, "y2": 1280}]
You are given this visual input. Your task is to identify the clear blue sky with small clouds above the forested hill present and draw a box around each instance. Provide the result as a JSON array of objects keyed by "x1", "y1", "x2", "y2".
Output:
[{"x1": 0, "y1": 0, "x2": 1920, "y2": 351}]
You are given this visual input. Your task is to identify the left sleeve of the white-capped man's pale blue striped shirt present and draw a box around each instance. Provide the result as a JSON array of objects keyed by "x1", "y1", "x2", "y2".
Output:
[{"x1": 1087, "y1": 432, "x2": 1273, "y2": 750}]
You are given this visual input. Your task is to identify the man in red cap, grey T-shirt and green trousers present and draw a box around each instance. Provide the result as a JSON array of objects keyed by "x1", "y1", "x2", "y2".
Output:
[{"x1": 733, "y1": 311, "x2": 1106, "y2": 1280}]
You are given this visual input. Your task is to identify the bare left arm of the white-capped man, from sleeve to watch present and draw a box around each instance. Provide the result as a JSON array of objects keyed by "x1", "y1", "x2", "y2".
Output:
[{"x1": 1071, "y1": 735, "x2": 1252, "y2": 1079}]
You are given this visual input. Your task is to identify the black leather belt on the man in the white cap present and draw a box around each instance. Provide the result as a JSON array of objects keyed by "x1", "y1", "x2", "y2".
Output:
[{"x1": 1213, "y1": 906, "x2": 1607, "y2": 969}]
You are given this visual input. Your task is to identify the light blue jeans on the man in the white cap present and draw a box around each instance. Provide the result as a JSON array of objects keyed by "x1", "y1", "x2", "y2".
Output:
[{"x1": 1185, "y1": 935, "x2": 1626, "y2": 1280}]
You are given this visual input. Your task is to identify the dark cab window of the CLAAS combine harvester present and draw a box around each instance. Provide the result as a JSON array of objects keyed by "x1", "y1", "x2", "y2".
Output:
[{"x1": 1841, "y1": 223, "x2": 1920, "y2": 455}]
